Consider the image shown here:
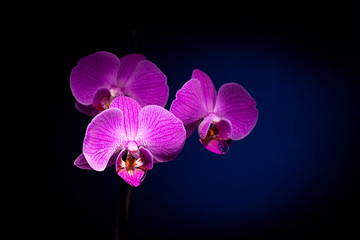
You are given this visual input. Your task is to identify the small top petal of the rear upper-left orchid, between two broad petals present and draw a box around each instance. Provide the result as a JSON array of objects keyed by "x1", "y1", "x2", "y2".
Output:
[{"x1": 117, "y1": 53, "x2": 146, "y2": 87}]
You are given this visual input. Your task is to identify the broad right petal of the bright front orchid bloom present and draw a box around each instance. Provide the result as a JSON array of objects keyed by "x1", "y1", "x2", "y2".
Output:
[{"x1": 135, "y1": 105, "x2": 186, "y2": 163}]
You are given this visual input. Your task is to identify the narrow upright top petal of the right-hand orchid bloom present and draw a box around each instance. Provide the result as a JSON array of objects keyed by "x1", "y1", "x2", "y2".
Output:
[{"x1": 191, "y1": 69, "x2": 216, "y2": 112}]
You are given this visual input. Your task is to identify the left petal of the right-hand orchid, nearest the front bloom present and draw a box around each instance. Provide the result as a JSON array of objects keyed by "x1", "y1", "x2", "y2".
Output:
[{"x1": 170, "y1": 79, "x2": 207, "y2": 137}]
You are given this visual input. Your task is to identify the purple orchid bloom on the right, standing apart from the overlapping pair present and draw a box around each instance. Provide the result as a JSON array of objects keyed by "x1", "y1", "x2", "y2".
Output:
[{"x1": 170, "y1": 69, "x2": 258, "y2": 154}]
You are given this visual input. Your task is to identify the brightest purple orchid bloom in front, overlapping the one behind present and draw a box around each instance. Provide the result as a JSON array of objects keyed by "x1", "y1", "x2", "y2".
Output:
[{"x1": 75, "y1": 96, "x2": 186, "y2": 187}]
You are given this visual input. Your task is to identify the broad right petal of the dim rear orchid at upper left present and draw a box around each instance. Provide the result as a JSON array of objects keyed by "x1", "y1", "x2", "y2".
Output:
[{"x1": 124, "y1": 60, "x2": 169, "y2": 107}]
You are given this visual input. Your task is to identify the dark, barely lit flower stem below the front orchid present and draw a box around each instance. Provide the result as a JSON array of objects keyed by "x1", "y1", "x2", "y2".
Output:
[{"x1": 114, "y1": 179, "x2": 134, "y2": 240}]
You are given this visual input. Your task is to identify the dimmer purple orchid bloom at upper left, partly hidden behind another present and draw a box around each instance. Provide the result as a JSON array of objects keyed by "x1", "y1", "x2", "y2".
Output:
[{"x1": 70, "y1": 51, "x2": 169, "y2": 116}]
